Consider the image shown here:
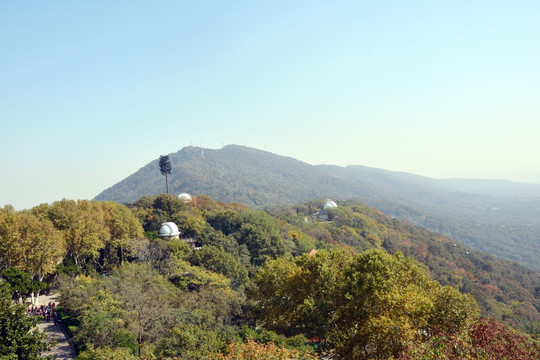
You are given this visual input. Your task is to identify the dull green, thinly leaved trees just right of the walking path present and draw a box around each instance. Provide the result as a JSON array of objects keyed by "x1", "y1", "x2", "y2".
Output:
[{"x1": 59, "y1": 262, "x2": 178, "y2": 358}]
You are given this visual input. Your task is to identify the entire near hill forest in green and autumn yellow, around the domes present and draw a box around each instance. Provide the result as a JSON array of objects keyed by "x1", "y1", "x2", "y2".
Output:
[{"x1": 0, "y1": 194, "x2": 540, "y2": 359}]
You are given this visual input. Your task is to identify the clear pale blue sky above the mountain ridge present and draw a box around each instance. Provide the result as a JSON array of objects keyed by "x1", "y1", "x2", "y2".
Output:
[{"x1": 0, "y1": 0, "x2": 540, "y2": 210}]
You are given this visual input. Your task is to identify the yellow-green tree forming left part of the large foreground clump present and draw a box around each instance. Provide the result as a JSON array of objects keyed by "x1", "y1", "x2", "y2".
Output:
[{"x1": 254, "y1": 249, "x2": 352, "y2": 338}]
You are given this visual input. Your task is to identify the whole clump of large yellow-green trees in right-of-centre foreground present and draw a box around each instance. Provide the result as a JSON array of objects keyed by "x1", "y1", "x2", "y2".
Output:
[{"x1": 255, "y1": 250, "x2": 479, "y2": 359}]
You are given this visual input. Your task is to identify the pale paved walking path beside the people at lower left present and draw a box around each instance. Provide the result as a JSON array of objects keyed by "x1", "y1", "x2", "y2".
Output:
[{"x1": 32, "y1": 294, "x2": 77, "y2": 360}]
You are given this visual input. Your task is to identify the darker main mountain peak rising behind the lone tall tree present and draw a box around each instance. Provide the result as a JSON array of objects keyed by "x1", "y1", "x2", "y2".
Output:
[{"x1": 96, "y1": 145, "x2": 361, "y2": 207}]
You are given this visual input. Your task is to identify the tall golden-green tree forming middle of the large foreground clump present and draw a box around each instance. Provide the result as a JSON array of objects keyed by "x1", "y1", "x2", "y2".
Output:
[{"x1": 331, "y1": 250, "x2": 436, "y2": 359}]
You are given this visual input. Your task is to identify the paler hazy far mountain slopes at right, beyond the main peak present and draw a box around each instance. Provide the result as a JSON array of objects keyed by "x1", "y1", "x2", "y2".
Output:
[{"x1": 334, "y1": 166, "x2": 540, "y2": 270}]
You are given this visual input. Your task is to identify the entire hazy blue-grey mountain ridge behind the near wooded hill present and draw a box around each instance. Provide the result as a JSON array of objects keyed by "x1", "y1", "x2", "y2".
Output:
[{"x1": 95, "y1": 145, "x2": 540, "y2": 270}]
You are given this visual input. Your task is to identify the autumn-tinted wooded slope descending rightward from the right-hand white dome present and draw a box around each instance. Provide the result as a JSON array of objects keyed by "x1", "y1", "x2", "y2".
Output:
[{"x1": 267, "y1": 200, "x2": 540, "y2": 333}]
